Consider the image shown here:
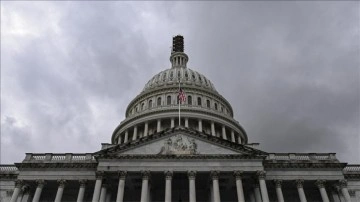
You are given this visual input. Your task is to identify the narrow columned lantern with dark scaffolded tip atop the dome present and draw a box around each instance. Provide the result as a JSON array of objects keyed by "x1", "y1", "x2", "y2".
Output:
[{"x1": 170, "y1": 35, "x2": 189, "y2": 68}]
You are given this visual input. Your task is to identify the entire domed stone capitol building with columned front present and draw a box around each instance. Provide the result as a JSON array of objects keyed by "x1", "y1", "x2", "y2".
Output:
[{"x1": 0, "y1": 35, "x2": 360, "y2": 202}]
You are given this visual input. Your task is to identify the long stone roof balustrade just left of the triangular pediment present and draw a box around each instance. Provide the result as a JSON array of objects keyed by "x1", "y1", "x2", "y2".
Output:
[{"x1": 23, "y1": 153, "x2": 95, "y2": 162}]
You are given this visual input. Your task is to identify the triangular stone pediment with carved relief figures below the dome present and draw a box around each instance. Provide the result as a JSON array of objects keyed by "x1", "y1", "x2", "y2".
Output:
[{"x1": 95, "y1": 128, "x2": 265, "y2": 158}]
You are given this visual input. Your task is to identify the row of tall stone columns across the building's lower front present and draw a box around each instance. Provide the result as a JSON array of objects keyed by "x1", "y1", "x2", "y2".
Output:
[{"x1": 11, "y1": 170, "x2": 351, "y2": 202}]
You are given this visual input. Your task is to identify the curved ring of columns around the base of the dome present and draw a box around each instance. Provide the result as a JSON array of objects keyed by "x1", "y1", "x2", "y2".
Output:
[{"x1": 116, "y1": 118, "x2": 244, "y2": 144}]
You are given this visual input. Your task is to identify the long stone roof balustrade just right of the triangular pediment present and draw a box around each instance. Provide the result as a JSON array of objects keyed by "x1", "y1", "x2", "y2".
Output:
[{"x1": 266, "y1": 153, "x2": 337, "y2": 161}]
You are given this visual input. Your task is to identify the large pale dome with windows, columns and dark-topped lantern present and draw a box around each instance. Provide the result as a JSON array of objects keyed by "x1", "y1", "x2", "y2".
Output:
[{"x1": 112, "y1": 35, "x2": 248, "y2": 144}]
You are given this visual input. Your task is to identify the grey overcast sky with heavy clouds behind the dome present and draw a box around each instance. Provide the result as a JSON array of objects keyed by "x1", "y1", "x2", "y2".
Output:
[{"x1": 1, "y1": 1, "x2": 360, "y2": 164}]
